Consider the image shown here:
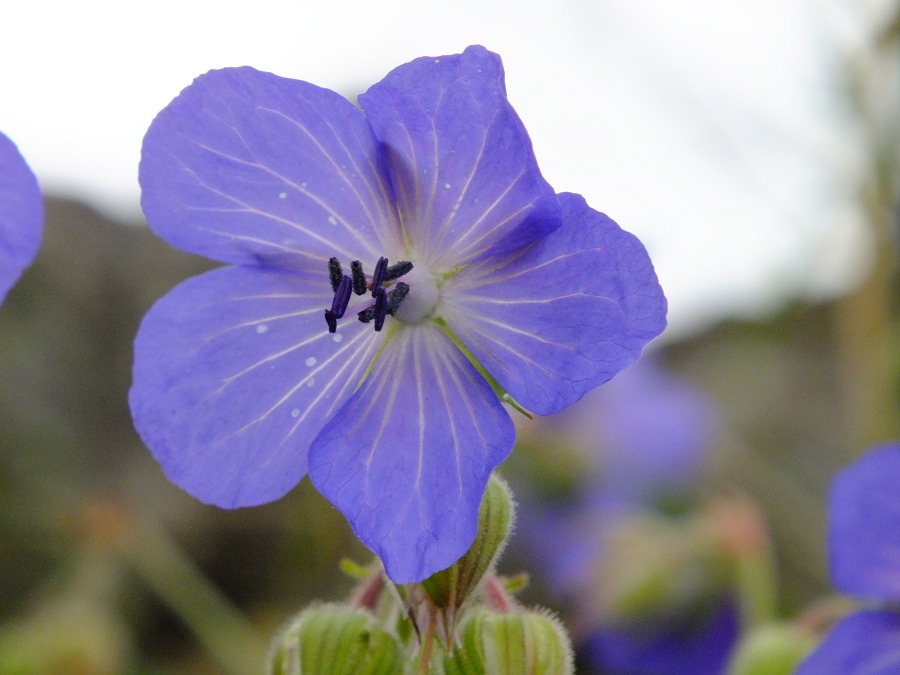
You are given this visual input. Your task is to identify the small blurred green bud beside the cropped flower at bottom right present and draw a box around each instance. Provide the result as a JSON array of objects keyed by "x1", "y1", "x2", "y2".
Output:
[{"x1": 728, "y1": 623, "x2": 816, "y2": 675}]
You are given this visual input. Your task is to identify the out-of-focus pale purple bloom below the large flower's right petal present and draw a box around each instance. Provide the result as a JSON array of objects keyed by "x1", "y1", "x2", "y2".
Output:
[{"x1": 513, "y1": 357, "x2": 719, "y2": 590}]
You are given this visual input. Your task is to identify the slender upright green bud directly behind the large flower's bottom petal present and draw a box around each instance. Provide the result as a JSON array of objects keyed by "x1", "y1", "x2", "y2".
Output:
[{"x1": 422, "y1": 475, "x2": 515, "y2": 616}]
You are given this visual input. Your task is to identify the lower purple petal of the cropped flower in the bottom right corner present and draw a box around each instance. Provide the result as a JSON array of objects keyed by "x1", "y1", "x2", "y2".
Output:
[{"x1": 795, "y1": 612, "x2": 900, "y2": 675}]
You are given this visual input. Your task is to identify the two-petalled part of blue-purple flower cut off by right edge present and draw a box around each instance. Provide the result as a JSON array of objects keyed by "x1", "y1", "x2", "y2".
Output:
[{"x1": 797, "y1": 443, "x2": 900, "y2": 675}]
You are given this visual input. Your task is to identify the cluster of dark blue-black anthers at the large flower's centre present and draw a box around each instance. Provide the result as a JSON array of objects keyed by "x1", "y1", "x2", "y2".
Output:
[{"x1": 325, "y1": 257, "x2": 416, "y2": 333}]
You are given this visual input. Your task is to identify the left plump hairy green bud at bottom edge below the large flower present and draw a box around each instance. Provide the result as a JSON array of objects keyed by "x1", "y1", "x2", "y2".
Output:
[{"x1": 268, "y1": 605, "x2": 406, "y2": 675}]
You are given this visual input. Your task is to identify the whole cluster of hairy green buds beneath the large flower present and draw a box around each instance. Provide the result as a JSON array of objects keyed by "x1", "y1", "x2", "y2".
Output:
[{"x1": 268, "y1": 476, "x2": 574, "y2": 675}]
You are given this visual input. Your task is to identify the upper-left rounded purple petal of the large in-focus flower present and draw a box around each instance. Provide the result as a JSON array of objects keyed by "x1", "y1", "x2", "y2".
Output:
[{"x1": 139, "y1": 67, "x2": 402, "y2": 273}]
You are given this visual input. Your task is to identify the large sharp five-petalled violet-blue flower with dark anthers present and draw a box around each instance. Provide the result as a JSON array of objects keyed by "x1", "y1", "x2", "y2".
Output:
[{"x1": 130, "y1": 47, "x2": 666, "y2": 583}]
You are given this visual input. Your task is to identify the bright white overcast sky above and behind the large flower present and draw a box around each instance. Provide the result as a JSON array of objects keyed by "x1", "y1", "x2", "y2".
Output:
[{"x1": 0, "y1": 0, "x2": 866, "y2": 335}]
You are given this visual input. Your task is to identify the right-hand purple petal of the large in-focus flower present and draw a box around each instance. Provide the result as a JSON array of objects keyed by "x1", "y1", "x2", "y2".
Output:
[{"x1": 443, "y1": 194, "x2": 666, "y2": 415}]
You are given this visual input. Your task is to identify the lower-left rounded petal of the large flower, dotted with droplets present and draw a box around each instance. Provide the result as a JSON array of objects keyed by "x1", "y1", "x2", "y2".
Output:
[{"x1": 129, "y1": 267, "x2": 382, "y2": 508}]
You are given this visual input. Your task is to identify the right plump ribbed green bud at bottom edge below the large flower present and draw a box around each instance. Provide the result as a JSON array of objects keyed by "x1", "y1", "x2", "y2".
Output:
[{"x1": 444, "y1": 609, "x2": 575, "y2": 675}]
